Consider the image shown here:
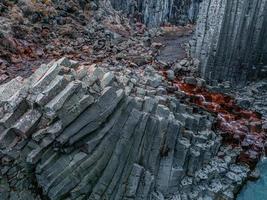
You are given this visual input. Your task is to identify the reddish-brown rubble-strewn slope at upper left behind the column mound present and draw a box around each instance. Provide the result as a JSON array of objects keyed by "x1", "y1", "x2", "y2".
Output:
[{"x1": 0, "y1": 0, "x2": 131, "y2": 83}]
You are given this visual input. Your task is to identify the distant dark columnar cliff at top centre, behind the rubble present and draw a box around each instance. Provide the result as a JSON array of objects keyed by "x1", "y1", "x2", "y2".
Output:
[{"x1": 111, "y1": 0, "x2": 201, "y2": 27}]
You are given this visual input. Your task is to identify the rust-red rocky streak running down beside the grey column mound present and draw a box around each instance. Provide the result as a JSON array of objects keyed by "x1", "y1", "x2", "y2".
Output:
[{"x1": 173, "y1": 80, "x2": 266, "y2": 167}]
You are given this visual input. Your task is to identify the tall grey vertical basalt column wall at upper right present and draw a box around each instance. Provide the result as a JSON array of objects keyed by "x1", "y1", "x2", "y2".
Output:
[{"x1": 193, "y1": 0, "x2": 267, "y2": 83}]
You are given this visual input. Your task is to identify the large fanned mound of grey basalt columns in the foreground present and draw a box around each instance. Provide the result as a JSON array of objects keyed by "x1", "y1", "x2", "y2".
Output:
[{"x1": 0, "y1": 58, "x2": 252, "y2": 200}]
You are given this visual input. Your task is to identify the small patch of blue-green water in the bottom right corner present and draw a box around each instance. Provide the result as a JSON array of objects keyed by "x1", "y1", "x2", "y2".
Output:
[{"x1": 237, "y1": 158, "x2": 267, "y2": 200}]
